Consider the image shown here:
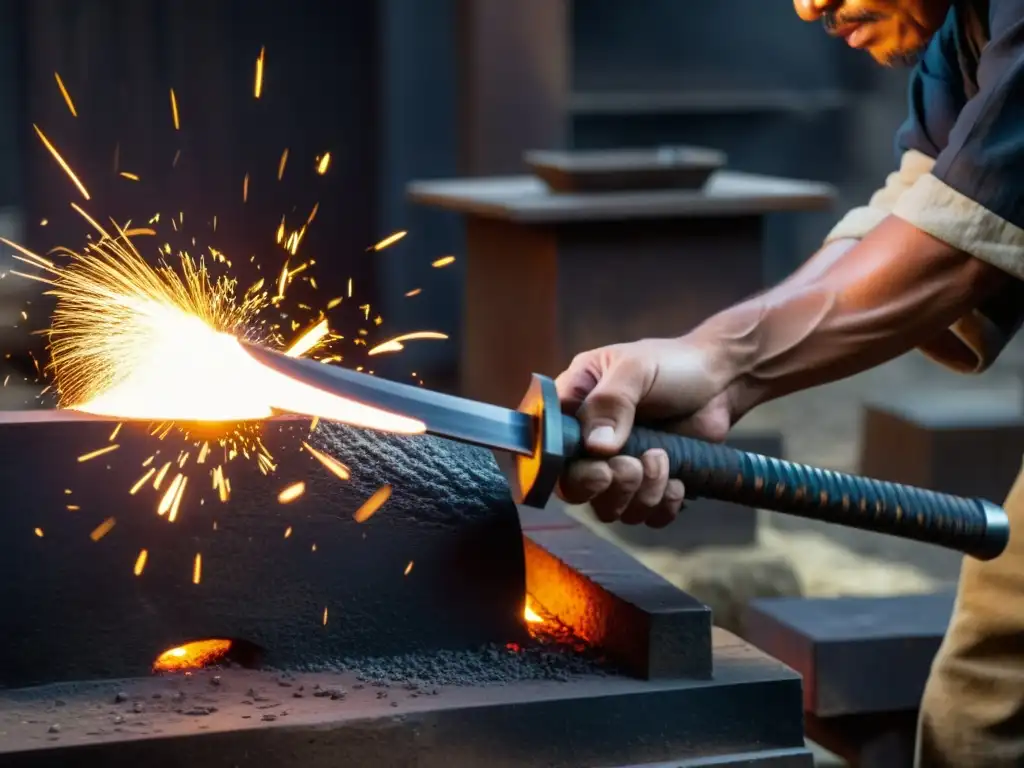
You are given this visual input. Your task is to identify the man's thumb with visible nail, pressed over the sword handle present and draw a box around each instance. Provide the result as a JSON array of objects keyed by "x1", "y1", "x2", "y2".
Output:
[{"x1": 577, "y1": 366, "x2": 642, "y2": 456}]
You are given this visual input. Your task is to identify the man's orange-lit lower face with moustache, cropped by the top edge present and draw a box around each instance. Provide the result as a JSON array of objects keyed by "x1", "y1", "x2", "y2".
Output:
[{"x1": 794, "y1": 0, "x2": 952, "y2": 65}]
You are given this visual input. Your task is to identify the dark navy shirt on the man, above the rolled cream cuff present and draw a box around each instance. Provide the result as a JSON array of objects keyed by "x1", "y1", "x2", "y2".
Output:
[{"x1": 897, "y1": 0, "x2": 1024, "y2": 228}]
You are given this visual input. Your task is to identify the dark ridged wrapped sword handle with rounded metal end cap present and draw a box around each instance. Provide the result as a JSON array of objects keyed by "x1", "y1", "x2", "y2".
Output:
[{"x1": 585, "y1": 427, "x2": 1010, "y2": 560}]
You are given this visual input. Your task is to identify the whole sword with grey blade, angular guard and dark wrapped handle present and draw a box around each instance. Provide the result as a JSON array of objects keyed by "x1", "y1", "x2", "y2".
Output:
[{"x1": 246, "y1": 345, "x2": 1010, "y2": 560}]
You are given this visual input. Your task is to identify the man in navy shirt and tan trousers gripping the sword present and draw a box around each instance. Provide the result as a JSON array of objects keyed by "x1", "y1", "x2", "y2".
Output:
[{"x1": 558, "y1": 0, "x2": 1024, "y2": 768}]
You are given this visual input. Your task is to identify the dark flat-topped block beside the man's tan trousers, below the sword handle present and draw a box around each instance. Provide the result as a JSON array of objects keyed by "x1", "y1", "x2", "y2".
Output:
[{"x1": 742, "y1": 593, "x2": 953, "y2": 718}]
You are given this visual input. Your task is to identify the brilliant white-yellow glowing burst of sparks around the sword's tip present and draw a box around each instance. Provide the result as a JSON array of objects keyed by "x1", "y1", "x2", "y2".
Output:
[{"x1": 37, "y1": 234, "x2": 426, "y2": 434}]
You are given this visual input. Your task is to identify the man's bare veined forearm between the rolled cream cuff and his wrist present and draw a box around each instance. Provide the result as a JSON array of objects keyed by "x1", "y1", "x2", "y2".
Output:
[{"x1": 691, "y1": 218, "x2": 1010, "y2": 417}]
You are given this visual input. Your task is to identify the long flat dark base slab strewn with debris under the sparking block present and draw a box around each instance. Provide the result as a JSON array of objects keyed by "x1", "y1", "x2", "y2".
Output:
[{"x1": 0, "y1": 630, "x2": 812, "y2": 768}]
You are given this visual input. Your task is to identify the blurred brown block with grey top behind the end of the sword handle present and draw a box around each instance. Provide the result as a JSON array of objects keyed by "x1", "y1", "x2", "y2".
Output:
[{"x1": 860, "y1": 392, "x2": 1024, "y2": 502}]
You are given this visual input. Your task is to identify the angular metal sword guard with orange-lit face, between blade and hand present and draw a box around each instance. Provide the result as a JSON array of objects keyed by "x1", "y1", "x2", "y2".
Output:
[{"x1": 509, "y1": 374, "x2": 580, "y2": 509}]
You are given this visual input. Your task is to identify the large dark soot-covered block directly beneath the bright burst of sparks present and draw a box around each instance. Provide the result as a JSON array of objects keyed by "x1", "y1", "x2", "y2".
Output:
[{"x1": 0, "y1": 420, "x2": 525, "y2": 687}]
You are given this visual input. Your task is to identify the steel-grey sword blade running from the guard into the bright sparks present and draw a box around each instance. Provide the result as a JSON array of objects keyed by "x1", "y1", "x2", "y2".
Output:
[{"x1": 244, "y1": 344, "x2": 535, "y2": 456}]
